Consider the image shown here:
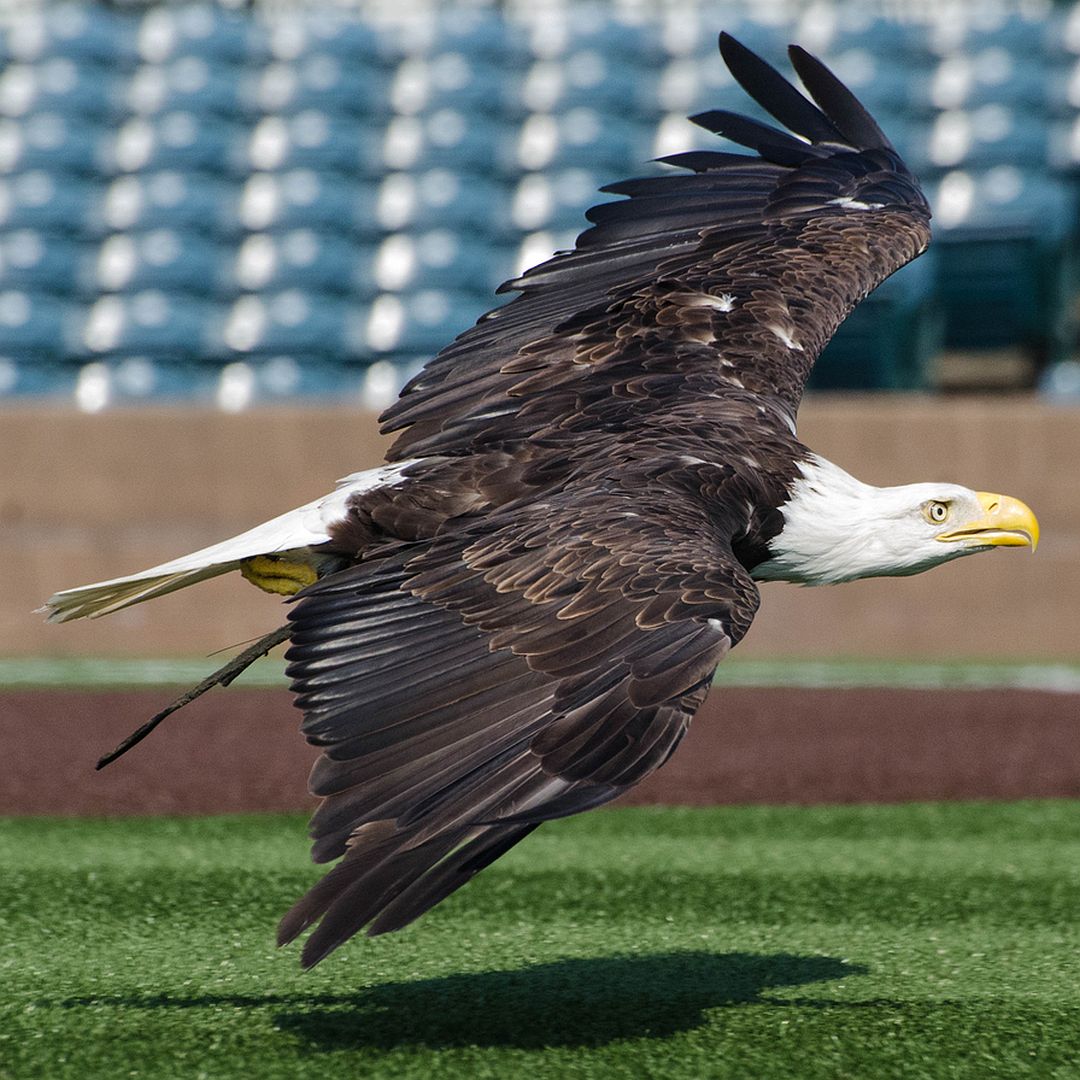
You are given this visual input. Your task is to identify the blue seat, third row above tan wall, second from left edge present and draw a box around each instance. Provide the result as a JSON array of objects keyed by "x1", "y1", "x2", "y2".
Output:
[{"x1": 84, "y1": 228, "x2": 228, "y2": 295}]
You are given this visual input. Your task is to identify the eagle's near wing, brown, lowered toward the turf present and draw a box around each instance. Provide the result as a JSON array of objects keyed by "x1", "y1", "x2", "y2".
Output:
[{"x1": 280, "y1": 459, "x2": 757, "y2": 964}]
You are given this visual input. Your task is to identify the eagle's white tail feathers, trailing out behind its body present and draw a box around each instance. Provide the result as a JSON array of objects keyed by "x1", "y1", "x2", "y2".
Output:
[{"x1": 38, "y1": 461, "x2": 410, "y2": 622}]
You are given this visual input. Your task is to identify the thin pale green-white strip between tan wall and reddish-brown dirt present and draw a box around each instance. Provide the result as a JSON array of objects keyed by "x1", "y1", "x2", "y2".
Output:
[{"x1": 0, "y1": 657, "x2": 1080, "y2": 693}]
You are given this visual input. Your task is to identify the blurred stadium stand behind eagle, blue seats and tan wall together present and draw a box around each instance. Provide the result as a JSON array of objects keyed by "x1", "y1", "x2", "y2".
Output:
[{"x1": 0, "y1": 0, "x2": 1080, "y2": 660}]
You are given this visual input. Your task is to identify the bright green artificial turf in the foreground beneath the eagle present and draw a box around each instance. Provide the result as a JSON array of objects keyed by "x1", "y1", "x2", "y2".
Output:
[{"x1": 0, "y1": 801, "x2": 1080, "y2": 1080}]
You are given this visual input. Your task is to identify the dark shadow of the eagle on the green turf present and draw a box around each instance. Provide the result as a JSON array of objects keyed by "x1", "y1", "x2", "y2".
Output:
[{"x1": 274, "y1": 951, "x2": 866, "y2": 1050}]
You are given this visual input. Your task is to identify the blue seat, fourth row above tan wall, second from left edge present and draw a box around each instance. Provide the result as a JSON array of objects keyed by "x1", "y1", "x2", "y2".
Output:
[{"x1": 86, "y1": 170, "x2": 242, "y2": 235}]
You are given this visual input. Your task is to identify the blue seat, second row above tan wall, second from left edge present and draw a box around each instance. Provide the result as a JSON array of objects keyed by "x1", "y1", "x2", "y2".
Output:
[{"x1": 72, "y1": 289, "x2": 217, "y2": 360}]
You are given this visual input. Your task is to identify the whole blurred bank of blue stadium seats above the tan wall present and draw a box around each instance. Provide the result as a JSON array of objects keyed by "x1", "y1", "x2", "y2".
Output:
[{"x1": 0, "y1": 0, "x2": 1080, "y2": 407}]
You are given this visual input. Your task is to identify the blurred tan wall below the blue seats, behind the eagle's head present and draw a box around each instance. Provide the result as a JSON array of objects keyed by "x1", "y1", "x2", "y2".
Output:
[{"x1": 0, "y1": 396, "x2": 1080, "y2": 660}]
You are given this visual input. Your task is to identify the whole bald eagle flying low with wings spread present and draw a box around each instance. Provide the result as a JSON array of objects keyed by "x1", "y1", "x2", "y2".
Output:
[{"x1": 44, "y1": 35, "x2": 1038, "y2": 966}]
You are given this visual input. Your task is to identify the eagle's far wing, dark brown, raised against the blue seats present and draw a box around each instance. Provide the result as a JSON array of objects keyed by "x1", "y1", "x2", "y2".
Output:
[{"x1": 382, "y1": 35, "x2": 930, "y2": 460}]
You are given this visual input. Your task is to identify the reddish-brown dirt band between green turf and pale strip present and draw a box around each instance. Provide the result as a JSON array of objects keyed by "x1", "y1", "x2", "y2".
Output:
[{"x1": 0, "y1": 687, "x2": 1080, "y2": 814}]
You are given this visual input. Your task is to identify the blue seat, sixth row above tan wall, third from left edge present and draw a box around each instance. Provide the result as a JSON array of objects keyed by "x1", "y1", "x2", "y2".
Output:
[{"x1": 239, "y1": 52, "x2": 392, "y2": 117}]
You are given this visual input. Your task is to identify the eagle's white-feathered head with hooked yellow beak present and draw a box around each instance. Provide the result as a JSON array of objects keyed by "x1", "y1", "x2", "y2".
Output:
[{"x1": 753, "y1": 457, "x2": 1039, "y2": 585}]
